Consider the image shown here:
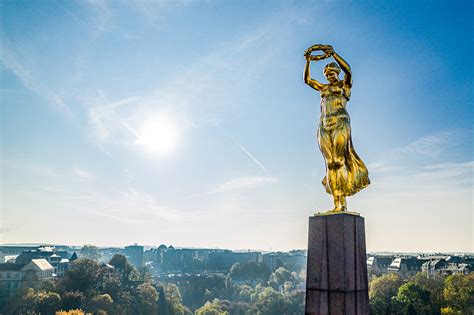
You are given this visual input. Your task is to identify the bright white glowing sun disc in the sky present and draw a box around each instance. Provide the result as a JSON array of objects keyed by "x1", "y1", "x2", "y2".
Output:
[{"x1": 137, "y1": 114, "x2": 179, "y2": 156}]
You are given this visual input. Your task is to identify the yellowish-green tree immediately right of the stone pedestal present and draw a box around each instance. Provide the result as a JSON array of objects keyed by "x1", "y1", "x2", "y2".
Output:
[{"x1": 369, "y1": 273, "x2": 402, "y2": 315}]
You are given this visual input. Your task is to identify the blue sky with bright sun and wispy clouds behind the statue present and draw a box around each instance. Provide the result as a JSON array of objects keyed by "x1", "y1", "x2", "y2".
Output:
[{"x1": 0, "y1": 0, "x2": 474, "y2": 251}]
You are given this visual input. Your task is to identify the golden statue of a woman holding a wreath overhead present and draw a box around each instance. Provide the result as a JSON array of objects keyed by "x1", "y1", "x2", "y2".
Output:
[{"x1": 304, "y1": 45, "x2": 370, "y2": 212}]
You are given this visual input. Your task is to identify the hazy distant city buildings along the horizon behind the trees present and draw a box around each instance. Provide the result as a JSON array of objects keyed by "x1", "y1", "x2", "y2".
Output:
[{"x1": 0, "y1": 244, "x2": 474, "y2": 300}]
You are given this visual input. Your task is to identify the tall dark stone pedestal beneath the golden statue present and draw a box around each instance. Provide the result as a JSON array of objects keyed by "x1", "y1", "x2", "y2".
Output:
[{"x1": 305, "y1": 213, "x2": 369, "y2": 315}]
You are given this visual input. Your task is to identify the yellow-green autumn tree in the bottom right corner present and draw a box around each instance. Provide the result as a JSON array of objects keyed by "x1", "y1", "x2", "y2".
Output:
[{"x1": 443, "y1": 273, "x2": 474, "y2": 314}]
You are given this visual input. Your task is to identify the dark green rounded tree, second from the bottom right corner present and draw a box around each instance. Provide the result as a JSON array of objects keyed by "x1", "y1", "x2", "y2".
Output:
[{"x1": 394, "y1": 281, "x2": 431, "y2": 315}]
